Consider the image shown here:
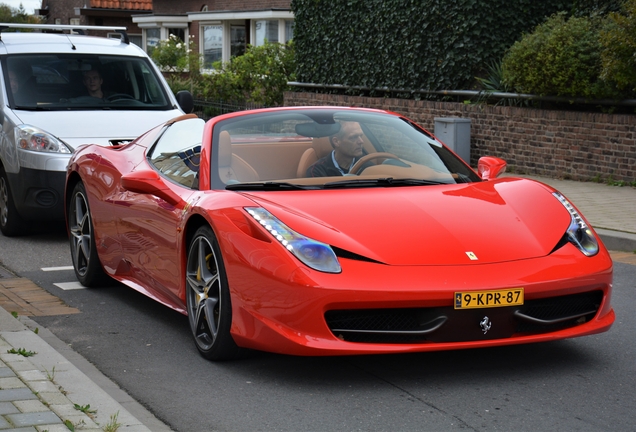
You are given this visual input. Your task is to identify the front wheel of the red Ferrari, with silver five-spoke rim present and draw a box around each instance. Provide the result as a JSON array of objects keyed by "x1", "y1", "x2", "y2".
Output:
[{"x1": 185, "y1": 226, "x2": 242, "y2": 360}]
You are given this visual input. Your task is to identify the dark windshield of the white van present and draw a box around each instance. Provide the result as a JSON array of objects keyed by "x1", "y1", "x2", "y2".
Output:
[{"x1": 2, "y1": 54, "x2": 171, "y2": 111}]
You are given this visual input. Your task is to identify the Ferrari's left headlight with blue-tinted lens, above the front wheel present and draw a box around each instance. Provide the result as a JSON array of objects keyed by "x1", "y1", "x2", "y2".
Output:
[{"x1": 245, "y1": 207, "x2": 342, "y2": 273}]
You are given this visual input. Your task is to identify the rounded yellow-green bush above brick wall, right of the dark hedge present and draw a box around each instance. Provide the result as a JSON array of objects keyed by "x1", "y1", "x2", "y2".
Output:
[{"x1": 502, "y1": 13, "x2": 615, "y2": 98}]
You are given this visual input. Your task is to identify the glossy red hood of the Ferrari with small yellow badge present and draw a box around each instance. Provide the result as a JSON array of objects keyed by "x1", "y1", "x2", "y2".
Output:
[{"x1": 245, "y1": 178, "x2": 570, "y2": 265}]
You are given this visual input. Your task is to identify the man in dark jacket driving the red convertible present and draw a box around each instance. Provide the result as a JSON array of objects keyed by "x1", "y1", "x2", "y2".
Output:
[{"x1": 307, "y1": 121, "x2": 364, "y2": 177}]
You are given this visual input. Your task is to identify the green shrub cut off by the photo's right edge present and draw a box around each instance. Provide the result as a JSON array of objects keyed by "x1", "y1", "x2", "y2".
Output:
[{"x1": 600, "y1": 0, "x2": 636, "y2": 92}]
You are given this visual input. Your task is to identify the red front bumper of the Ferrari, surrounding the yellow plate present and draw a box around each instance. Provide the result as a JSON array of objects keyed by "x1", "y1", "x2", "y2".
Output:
[{"x1": 225, "y1": 238, "x2": 614, "y2": 355}]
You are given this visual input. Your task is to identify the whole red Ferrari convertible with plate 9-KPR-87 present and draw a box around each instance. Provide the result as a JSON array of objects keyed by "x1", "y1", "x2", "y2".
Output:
[{"x1": 66, "y1": 107, "x2": 614, "y2": 360}]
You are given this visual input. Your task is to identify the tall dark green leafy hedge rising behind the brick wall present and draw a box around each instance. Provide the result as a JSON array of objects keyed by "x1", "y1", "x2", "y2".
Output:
[{"x1": 291, "y1": 0, "x2": 576, "y2": 90}]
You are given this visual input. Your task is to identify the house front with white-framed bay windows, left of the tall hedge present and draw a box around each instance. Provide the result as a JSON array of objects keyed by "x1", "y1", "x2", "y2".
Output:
[{"x1": 132, "y1": 0, "x2": 294, "y2": 67}]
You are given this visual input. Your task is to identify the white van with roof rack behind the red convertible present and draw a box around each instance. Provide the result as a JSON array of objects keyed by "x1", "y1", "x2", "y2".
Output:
[{"x1": 0, "y1": 24, "x2": 193, "y2": 236}]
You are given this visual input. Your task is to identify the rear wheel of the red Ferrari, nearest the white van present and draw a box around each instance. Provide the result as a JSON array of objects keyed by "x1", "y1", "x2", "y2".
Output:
[{"x1": 66, "y1": 182, "x2": 106, "y2": 287}]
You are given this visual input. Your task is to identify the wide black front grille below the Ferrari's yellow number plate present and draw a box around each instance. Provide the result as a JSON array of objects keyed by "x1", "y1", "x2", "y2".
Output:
[{"x1": 325, "y1": 291, "x2": 603, "y2": 343}]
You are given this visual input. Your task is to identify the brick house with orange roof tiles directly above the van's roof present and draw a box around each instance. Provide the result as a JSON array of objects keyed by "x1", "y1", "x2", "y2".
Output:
[{"x1": 35, "y1": 0, "x2": 152, "y2": 46}]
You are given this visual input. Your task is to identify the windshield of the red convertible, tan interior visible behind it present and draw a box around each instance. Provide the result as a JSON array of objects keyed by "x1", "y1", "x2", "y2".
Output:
[{"x1": 211, "y1": 109, "x2": 480, "y2": 190}]
